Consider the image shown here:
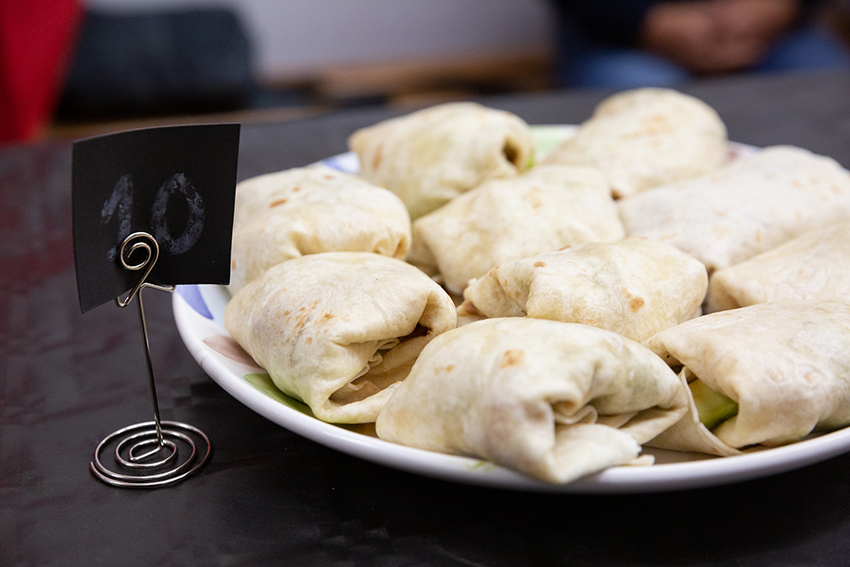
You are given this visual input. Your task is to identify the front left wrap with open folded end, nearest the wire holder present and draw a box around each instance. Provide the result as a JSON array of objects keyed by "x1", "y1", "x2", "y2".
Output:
[{"x1": 224, "y1": 252, "x2": 457, "y2": 423}]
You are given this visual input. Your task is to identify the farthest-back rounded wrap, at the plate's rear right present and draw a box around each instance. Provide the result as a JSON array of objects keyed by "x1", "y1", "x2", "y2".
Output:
[{"x1": 544, "y1": 88, "x2": 727, "y2": 198}]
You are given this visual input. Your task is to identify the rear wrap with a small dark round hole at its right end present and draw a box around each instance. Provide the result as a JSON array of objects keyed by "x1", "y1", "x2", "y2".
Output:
[{"x1": 348, "y1": 102, "x2": 534, "y2": 219}]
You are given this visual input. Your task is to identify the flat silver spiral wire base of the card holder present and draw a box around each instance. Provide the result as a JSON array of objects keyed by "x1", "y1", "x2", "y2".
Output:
[{"x1": 89, "y1": 421, "x2": 212, "y2": 488}]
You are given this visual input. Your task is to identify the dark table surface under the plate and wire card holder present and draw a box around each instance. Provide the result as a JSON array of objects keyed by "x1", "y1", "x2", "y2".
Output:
[{"x1": 0, "y1": 74, "x2": 850, "y2": 567}]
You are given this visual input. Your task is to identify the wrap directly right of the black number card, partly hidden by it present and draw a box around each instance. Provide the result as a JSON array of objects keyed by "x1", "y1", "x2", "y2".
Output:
[{"x1": 229, "y1": 165, "x2": 410, "y2": 293}]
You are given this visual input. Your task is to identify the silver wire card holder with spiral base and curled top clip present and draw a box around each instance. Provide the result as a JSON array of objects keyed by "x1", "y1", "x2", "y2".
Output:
[{"x1": 89, "y1": 232, "x2": 212, "y2": 488}]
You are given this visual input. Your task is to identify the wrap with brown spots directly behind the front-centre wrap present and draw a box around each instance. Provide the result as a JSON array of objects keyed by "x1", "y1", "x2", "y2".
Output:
[{"x1": 459, "y1": 237, "x2": 708, "y2": 342}]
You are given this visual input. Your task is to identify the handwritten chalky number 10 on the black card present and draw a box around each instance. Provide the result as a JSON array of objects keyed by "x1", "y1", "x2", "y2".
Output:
[{"x1": 100, "y1": 173, "x2": 204, "y2": 260}]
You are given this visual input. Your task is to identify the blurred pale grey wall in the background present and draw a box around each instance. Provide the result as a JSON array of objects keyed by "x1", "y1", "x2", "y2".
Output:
[{"x1": 87, "y1": 0, "x2": 552, "y2": 81}]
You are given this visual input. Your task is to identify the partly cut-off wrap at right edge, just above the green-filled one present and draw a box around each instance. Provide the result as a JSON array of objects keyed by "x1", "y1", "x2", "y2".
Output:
[{"x1": 707, "y1": 222, "x2": 850, "y2": 311}]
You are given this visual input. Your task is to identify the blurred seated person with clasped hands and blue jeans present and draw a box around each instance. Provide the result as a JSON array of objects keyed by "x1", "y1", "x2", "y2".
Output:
[{"x1": 552, "y1": 0, "x2": 850, "y2": 88}]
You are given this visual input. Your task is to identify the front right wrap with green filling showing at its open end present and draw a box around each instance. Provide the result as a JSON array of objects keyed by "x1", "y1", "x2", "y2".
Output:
[{"x1": 645, "y1": 301, "x2": 850, "y2": 455}]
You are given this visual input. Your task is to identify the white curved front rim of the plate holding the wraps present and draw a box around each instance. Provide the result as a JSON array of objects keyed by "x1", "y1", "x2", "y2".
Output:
[{"x1": 172, "y1": 285, "x2": 850, "y2": 493}]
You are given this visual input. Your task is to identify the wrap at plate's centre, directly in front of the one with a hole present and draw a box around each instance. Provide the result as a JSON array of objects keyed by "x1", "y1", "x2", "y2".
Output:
[{"x1": 408, "y1": 165, "x2": 624, "y2": 293}]
